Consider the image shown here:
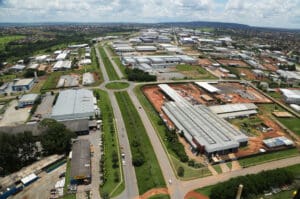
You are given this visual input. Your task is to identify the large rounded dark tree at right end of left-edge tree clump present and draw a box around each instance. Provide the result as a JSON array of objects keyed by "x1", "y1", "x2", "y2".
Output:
[{"x1": 39, "y1": 119, "x2": 76, "y2": 155}]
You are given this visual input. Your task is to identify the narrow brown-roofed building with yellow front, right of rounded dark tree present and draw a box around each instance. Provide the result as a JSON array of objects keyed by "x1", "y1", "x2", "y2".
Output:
[{"x1": 70, "y1": 140, "x2": 91, "y2": 184}]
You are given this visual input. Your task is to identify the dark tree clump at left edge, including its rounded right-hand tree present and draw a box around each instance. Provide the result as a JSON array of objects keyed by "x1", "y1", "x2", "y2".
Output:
[{"x1": 0, "y1": 119, "x2": 76, "y2": 176}]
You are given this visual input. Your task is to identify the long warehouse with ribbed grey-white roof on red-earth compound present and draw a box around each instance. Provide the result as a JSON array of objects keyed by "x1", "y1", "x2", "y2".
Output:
[{"x1": 159, "y1": 84, "x2": 248, "y2": 157}]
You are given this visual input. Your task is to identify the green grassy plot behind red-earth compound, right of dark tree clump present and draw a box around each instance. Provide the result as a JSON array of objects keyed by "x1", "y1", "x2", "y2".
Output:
[{"x1": 176, "y1": 64, "x2": 216, "y2": 79}]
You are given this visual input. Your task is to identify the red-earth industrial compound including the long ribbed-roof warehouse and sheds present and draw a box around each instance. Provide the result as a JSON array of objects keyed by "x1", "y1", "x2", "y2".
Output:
[{"x1": 143, "y1": 82, "x2": 294, "y2": 159}]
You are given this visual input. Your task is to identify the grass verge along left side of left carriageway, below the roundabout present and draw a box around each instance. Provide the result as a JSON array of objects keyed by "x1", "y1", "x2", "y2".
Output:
[{"x1": 95, "y1": 90, "x2": 125, "y2": 197}]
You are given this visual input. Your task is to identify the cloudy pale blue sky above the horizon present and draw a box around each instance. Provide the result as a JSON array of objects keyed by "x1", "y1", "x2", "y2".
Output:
[{"x1": 0, "y1": 0, "x2": 300, "y2": 29}]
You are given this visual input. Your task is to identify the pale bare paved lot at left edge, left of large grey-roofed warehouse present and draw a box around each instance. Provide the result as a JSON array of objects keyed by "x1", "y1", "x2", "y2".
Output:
[{"x1": 0, "y1": 100, "x2": 31, "y2": 126}]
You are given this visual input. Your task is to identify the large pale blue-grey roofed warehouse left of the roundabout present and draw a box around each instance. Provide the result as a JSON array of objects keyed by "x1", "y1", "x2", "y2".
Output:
[{"x1": 51, "y1": 89, "x2": 95, "y2": 121}]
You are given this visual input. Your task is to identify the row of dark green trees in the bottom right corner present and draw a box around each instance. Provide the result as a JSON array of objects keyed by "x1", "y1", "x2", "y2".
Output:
[{"x1": 209, "y1": 169, "x2": 294, "y2": 199}]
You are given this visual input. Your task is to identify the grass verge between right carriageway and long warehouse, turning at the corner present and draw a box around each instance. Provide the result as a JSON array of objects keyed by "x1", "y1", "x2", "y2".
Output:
[{"x1": 134, "y1": 86, "x2": 211, "y2": 180}]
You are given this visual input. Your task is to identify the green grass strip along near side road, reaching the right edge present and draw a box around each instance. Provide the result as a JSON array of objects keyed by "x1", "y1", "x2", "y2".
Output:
[{"x1": 239, "y1": 149, "x2": 299, "y2": 167}]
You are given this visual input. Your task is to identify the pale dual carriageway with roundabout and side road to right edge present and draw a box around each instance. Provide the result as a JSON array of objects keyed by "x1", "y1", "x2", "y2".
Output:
[{"x1": 96, "y1": 43, "x2": 300, "y2": 199}]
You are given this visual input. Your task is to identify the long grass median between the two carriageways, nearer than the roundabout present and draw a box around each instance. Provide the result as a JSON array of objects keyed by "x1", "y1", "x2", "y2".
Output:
[{"x1": 115, "y1": 91, "x2": 166, "y2": 195}]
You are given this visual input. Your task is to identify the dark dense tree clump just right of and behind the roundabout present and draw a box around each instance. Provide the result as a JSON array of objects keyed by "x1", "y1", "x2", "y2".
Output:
[{"x1": 125, "y1": 68, "x2": 156, "y2": 82}]
